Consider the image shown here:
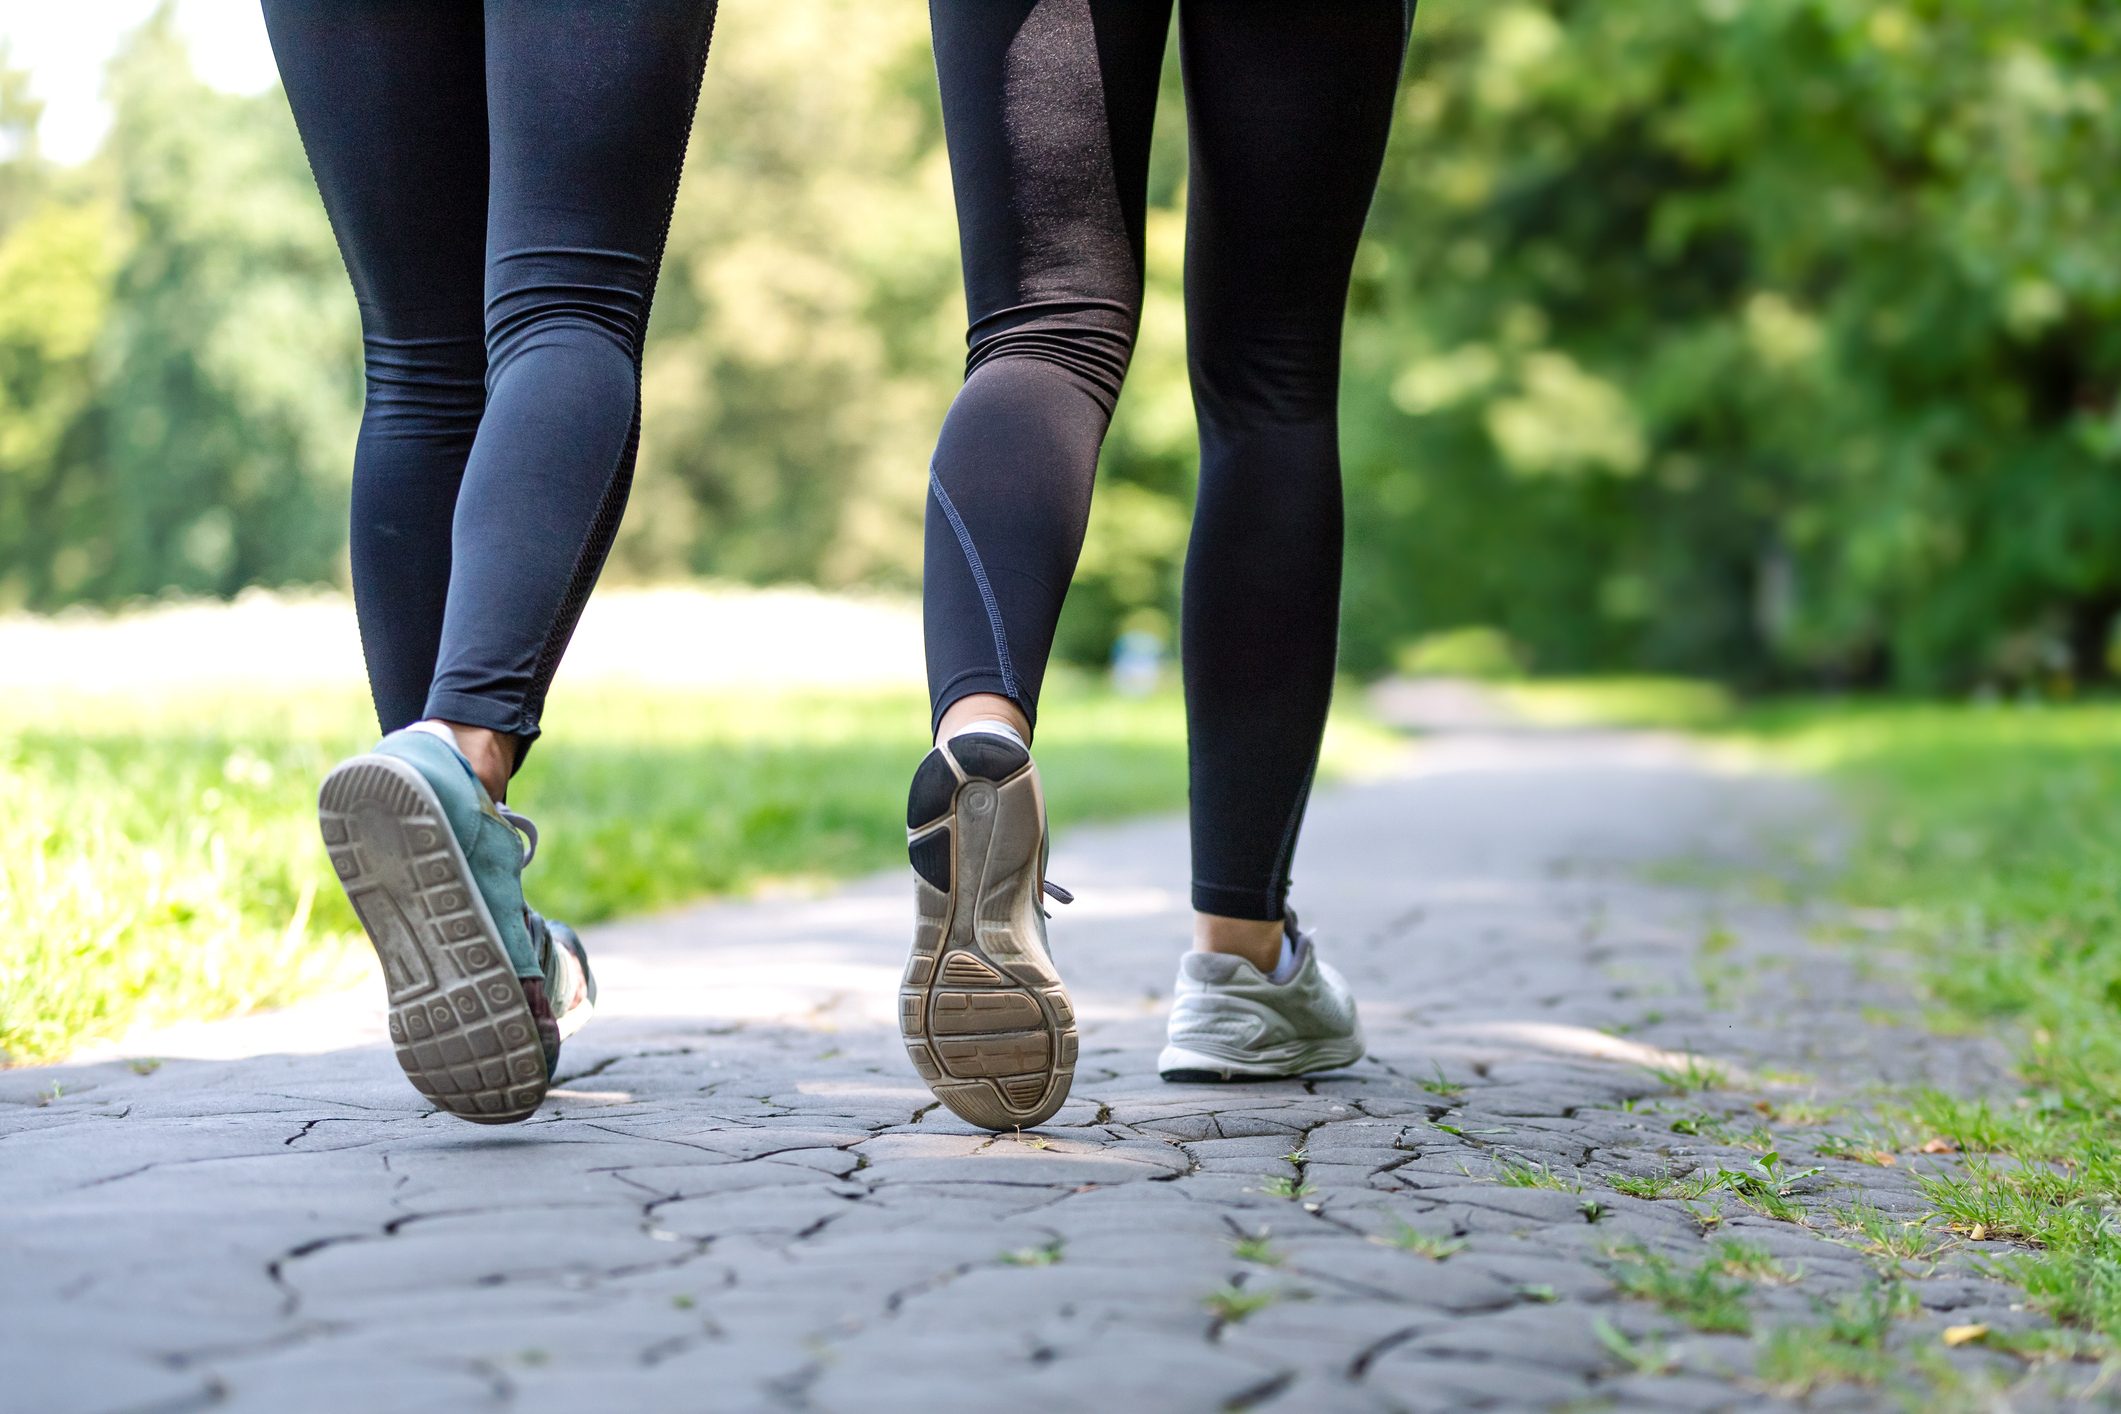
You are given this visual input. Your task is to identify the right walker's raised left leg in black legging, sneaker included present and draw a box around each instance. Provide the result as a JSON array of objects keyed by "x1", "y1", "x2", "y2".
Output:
[{"x1": 899, "y1": 0, "x2": 1169, "y2": 1128}]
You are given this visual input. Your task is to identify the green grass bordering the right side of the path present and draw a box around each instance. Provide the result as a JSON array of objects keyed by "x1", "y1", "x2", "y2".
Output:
[{"x1": 1504, "y1": 678, "x2": 2121, "y2": 1356}]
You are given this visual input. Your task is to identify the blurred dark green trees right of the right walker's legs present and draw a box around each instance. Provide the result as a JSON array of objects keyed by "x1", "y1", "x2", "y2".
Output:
[{"x1": 1347, "y1": 0, "x2": 2121, "y2": 687}]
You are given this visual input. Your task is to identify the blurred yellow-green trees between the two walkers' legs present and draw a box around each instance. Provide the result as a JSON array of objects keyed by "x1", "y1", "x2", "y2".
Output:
[{"x1": 615, "y1": 0, "x2": 963, "y2": 587}]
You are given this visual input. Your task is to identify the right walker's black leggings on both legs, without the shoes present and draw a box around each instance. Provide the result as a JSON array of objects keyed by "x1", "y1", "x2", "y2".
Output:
[{"x1": 925, "y1": 0, "x2": 1413, "y2": 920}]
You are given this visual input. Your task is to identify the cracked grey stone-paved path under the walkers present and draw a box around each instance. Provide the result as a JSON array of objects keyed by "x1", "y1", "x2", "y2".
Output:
[{"x1": 0, "y1": 731, "x2": 2083, "y2": 1414}]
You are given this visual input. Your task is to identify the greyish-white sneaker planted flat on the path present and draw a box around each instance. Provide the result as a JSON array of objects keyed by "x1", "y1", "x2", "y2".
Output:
[{"x1": 1156, "y1": 916, "x2": 1364, "y2": 1081}]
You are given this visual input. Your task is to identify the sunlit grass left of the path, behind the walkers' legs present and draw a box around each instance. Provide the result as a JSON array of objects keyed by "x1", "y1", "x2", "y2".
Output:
[{"x1": 0, "y1": 674, "x2": 1379, "y2": 1064}]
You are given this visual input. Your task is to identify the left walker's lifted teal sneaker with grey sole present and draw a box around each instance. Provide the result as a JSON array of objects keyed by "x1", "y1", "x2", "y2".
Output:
[{"x1": 316, "y1": 729, "x2": 596, "y2": 1124}]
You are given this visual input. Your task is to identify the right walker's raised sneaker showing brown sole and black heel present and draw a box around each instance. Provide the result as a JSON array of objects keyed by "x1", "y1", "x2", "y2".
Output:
[{"x1": 899, "y1": 736, "x2": 1077, "y2": 1130}]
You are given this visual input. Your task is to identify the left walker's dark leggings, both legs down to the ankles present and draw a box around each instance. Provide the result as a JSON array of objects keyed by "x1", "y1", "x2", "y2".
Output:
[{"x1": 265, "y1": 0, "x2": 715, "y2": 744}]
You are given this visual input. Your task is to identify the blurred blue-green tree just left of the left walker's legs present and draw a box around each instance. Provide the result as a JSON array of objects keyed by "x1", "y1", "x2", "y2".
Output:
[{"x1": 85, "y1": 6, "x2": 361, "y2": 598}]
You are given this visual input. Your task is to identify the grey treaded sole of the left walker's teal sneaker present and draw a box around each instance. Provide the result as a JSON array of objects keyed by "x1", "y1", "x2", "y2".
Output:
[{"x1": 316, "y1": 757, "x2": 549, "y2": 1124}]
